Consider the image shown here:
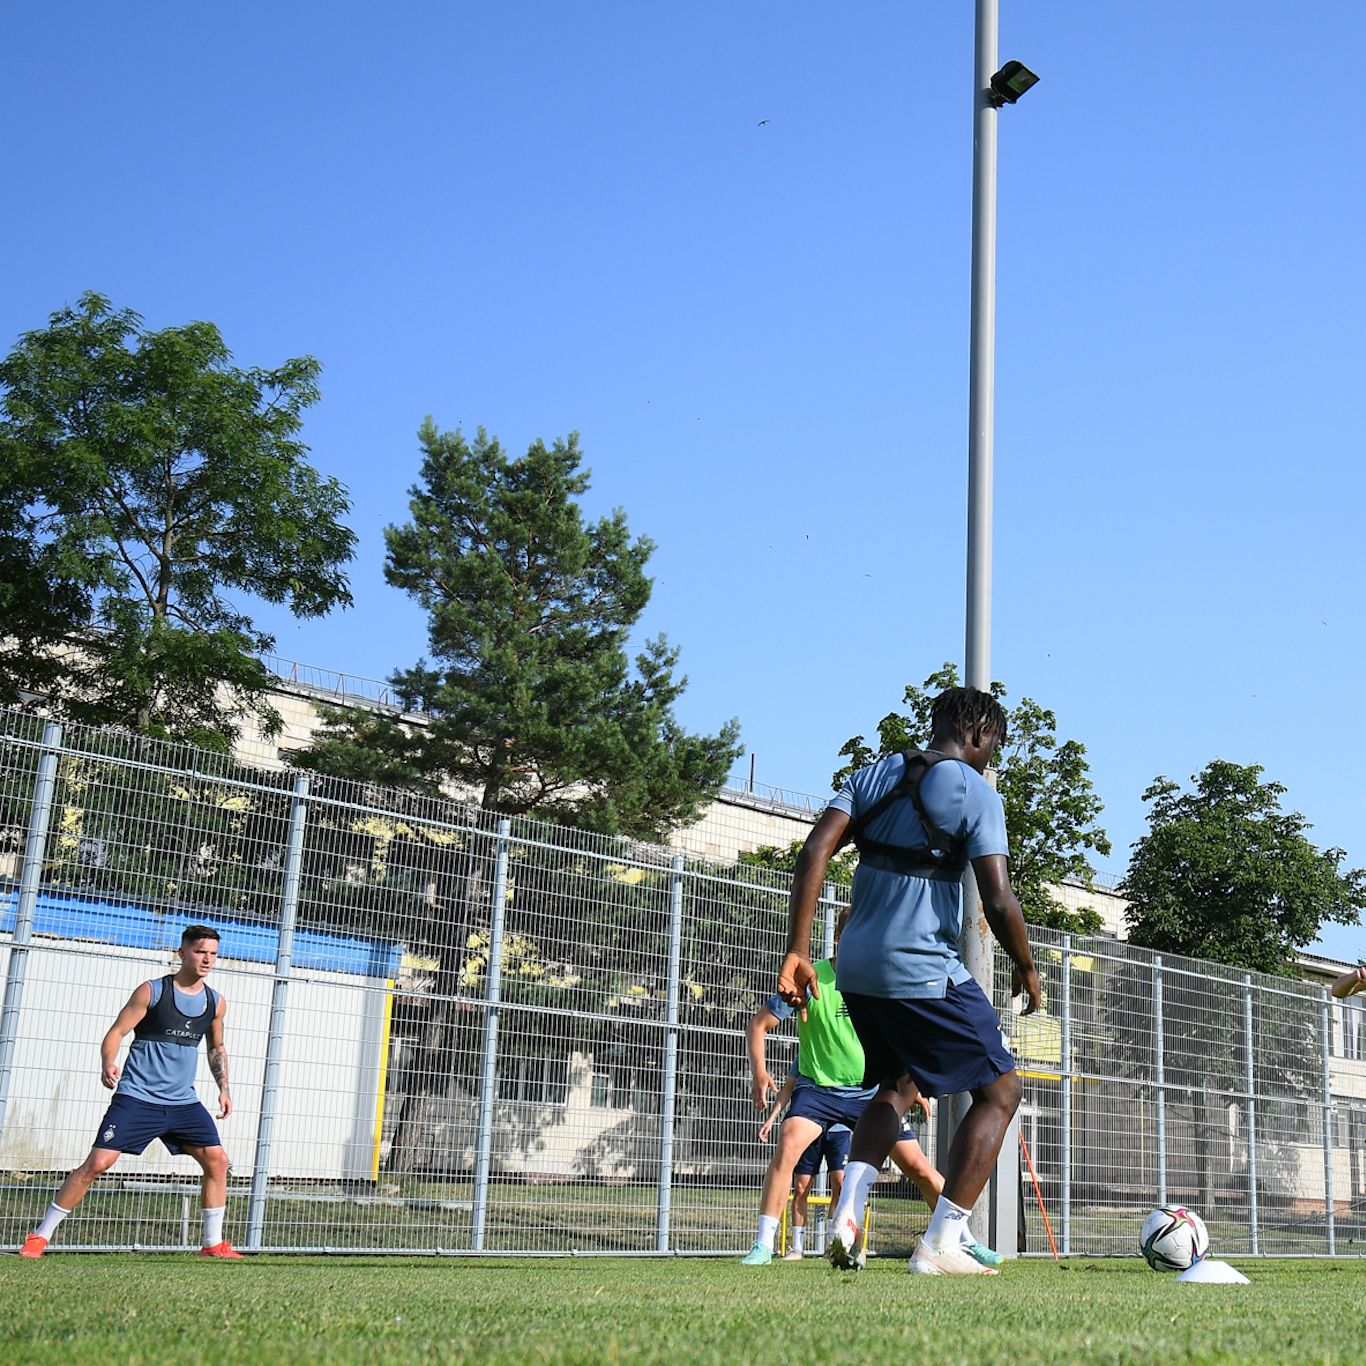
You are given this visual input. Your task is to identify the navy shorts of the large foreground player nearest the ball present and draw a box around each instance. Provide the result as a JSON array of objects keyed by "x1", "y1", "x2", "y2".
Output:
[{"x1": 843, "y1": 978, "x2": 1015, "y2": 1096}]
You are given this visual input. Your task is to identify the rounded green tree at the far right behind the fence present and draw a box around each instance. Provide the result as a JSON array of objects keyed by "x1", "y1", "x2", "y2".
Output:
[{"x1": 1120, "y1": 759, "x2": 1366, "y2": 974}]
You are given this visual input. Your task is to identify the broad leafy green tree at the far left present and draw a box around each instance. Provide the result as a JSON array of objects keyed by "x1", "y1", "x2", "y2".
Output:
[{"x1": 0, "y1": 294, "x2": 355, "y2": 747}]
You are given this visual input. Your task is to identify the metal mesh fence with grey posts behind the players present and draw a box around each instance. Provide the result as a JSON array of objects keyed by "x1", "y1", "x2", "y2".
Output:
[{"x1": 0, "y1": 713, "x2": 1366, "y2": 1254}]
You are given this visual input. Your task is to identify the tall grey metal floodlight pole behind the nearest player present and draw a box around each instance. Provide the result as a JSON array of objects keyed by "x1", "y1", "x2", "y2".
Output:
[{"x1": 951, "y1": 0, "x2": 1019, "y2": 1257}]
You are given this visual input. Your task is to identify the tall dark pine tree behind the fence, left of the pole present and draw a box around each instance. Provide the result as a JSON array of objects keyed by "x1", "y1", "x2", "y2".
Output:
[{"x1": 298, "y1": 418, "x2": 739, "y2": 837}]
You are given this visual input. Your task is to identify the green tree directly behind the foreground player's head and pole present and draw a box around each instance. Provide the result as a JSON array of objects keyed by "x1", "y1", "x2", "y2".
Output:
[{"x1": 832, "y1": 664, "x2": 1111, "y2": 934}]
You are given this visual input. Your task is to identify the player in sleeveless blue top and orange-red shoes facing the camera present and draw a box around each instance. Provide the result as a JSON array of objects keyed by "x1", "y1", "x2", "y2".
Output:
[{"x1": 19, "y1": 925, "x2": 242, "y2": 1261}]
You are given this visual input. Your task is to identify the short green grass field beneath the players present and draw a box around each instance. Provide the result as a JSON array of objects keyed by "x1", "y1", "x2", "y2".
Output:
[{"x1": 0, "y1": 1254, "x2": 1366, "y2": 1366}]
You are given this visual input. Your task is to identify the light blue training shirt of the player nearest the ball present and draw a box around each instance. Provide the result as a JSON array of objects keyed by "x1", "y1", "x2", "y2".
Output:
[{"x1": 831, "y1": 754, "x2": 1009, "y2": 1000}]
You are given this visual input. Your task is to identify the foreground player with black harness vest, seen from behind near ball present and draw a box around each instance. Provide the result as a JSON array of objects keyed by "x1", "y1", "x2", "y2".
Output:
[{"x1": 777, "y1": 687, "x2": 1040, "y2": 1276}]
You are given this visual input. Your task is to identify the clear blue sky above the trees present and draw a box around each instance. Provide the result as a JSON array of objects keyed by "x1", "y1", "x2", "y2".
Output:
[{"x1": 0, "y1": 0, "x2": 1366, "y2": 958}]
